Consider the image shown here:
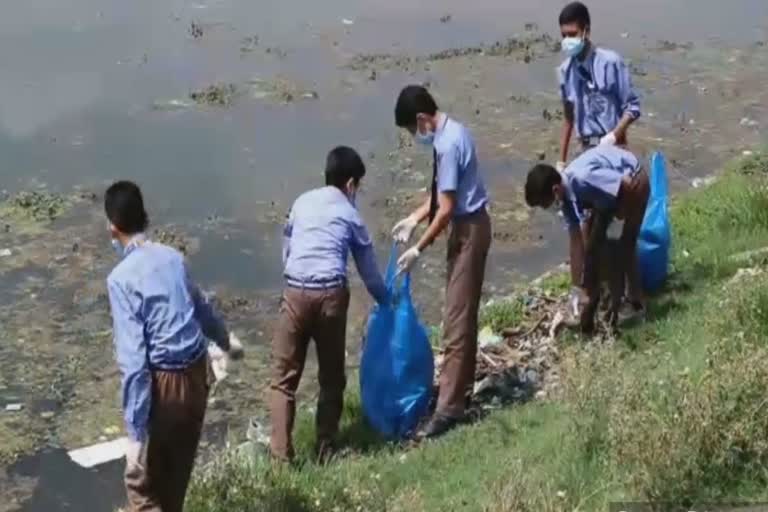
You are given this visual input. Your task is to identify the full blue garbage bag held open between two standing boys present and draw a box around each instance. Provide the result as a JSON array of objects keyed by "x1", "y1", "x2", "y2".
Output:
[{"x1": 360, "y1": 246, "x2": 435, "y2": 439}]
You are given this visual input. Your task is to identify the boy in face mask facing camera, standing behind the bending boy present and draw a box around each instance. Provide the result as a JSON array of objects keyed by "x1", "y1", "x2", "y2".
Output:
[{"x1": 556, "y1": 2, "x2": 640, "y2": 171}]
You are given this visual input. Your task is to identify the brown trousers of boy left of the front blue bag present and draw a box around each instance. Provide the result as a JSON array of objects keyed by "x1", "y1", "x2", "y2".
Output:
[{"x1": 270, "y1": 287, "x2": 349, "y2": 461}]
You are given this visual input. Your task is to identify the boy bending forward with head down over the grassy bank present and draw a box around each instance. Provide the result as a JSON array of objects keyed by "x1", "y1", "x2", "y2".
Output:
[{"x1": 525, "y1": 146, "x2": 650, "y2": 333}]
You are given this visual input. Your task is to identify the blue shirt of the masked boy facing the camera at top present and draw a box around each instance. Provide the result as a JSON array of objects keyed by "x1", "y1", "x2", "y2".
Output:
[{"x1": 558, "y1": 48, "x2": 640, "y2": 138}]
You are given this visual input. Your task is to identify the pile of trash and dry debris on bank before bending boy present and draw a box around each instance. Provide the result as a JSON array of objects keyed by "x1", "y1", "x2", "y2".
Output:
[{"x1": 435, "y1": 282, "x2": 573, "y2": 417}]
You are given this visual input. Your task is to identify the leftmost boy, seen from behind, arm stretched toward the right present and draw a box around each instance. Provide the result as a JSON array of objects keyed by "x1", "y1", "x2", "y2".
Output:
[{"x1": 104, "y1": 181, "x2": 243, "y2": 512}]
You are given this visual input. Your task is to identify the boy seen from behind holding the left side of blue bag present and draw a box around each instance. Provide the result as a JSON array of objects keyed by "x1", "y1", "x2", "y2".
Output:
[{"x1": 270, "y1": 146, "x2": 388, "y2": 462}]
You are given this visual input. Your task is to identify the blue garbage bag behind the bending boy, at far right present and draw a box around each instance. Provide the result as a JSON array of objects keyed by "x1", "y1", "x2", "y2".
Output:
[{"x1": 637, "y1": 152, "x2": 672, "y2": 292}]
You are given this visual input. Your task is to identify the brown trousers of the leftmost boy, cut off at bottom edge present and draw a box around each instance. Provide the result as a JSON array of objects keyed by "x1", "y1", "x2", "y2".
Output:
[{"x1": 125, "y1": 356, "x2": 209, "y2": 512}]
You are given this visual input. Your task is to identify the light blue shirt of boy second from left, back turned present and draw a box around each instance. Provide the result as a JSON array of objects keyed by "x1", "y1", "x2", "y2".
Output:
[{"x1": 283, "y1": 186, "x2": 388, "y2": 302}]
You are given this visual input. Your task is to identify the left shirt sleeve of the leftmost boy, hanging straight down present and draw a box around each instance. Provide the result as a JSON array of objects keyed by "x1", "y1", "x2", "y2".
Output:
[{"x1": 107, "y1": 280, "x2": 152, "y2": 442}]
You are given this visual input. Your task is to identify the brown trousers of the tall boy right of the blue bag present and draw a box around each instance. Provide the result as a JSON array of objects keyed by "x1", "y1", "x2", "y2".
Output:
[{"x1": 436, "y1": 210, "x2": 492, "y2": 418}]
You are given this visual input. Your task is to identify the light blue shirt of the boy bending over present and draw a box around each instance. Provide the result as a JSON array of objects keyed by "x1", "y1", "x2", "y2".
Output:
[{"x1": 562, "y1": 145, "x2": 640, "y2": 229}]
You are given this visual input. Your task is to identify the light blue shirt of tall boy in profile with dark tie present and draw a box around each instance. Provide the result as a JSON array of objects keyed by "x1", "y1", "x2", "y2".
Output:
[{"x1": 434, "y1": 114, "x2": 488, "y2": 218}]
